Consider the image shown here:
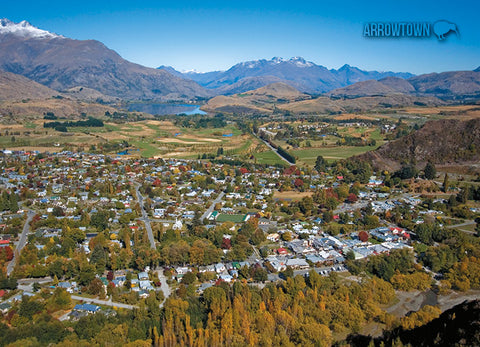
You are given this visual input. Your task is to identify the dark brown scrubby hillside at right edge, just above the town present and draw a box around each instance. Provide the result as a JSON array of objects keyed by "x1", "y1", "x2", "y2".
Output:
[{"x1": 355, "y1": 118, "x2": 480, "y2": 170}]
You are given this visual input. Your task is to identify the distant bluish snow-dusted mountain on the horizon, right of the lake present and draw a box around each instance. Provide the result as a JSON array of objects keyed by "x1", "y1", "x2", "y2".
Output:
[{"x1": 159, "y1": 57, "x2": 413, "y2": 94}]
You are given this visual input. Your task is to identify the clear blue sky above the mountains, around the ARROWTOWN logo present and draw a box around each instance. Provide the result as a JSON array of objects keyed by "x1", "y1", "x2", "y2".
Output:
[{"x1": 0, "y1": 0, "x2": 480, "y2": 74}]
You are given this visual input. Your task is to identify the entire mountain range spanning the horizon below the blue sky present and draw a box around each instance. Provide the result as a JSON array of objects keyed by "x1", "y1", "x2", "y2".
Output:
[{"x1": 0, "y1": 19, "x2": 480, "y2": 105}]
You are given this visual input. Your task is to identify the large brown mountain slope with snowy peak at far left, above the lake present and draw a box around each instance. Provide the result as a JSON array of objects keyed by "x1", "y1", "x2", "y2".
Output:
[{"x1": 0, "y1": 19, "x2": 209, "y2": 100}]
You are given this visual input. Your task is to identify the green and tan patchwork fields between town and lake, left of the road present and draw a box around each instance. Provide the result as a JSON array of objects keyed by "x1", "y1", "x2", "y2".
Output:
[{"x1": 0, "y1": 119, "x2": 258, "y2": 159}]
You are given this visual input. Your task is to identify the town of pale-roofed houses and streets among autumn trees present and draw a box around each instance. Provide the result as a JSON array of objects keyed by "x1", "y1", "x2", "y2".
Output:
[{"x1": 0, "y1": 144, "x2": 478, "y2": 346}]
